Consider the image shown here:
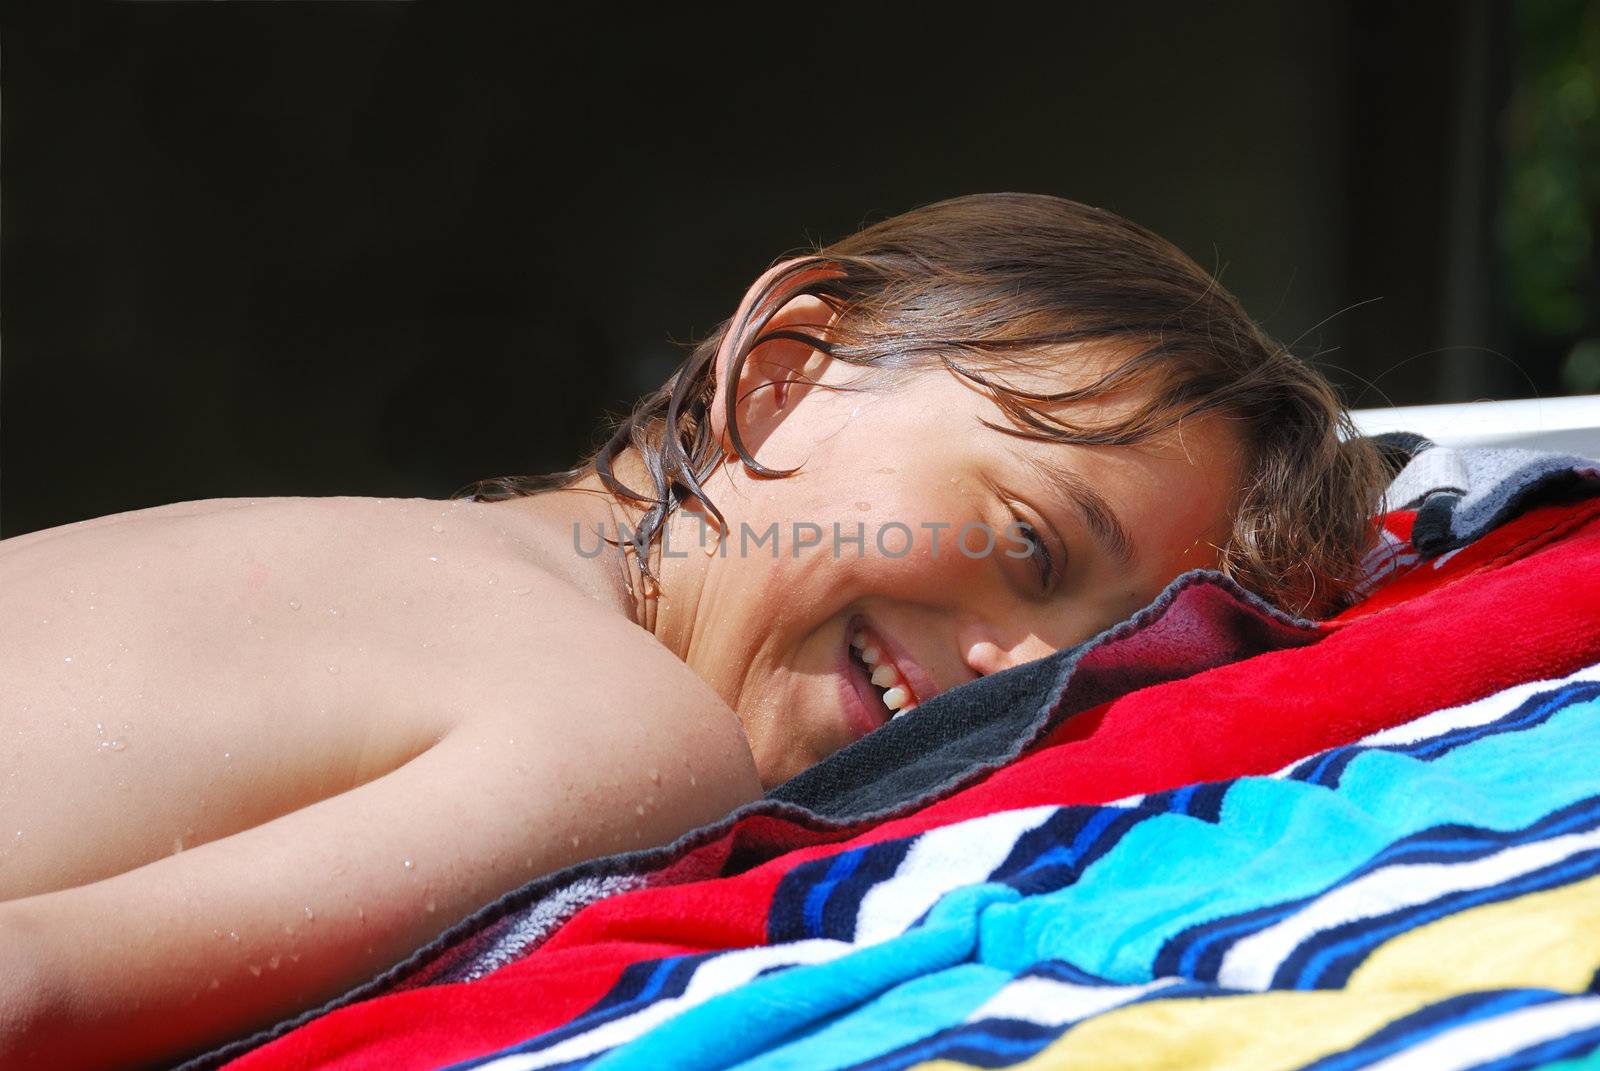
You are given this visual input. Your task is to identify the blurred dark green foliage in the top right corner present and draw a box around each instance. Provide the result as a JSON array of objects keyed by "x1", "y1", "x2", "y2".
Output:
[{"x1": 1499, "y1": 0, "x2": 1600, "y2": 394}]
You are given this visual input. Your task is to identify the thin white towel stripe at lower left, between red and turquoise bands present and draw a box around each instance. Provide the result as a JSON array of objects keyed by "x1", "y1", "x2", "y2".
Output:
[{"x1": 470, "y1": 938, "x2": 853, "y2": 1071}]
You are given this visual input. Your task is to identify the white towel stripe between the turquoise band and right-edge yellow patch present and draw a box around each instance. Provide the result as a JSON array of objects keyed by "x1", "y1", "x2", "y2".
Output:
[{"x1": 1218, "y1": 829, "x2": 1600, "y2": 989}]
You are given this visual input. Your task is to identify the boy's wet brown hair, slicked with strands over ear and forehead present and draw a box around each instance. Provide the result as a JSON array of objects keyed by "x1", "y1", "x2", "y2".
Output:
[{"x1": 458, "y1": 194, "x2": 1386, "y2": 615}]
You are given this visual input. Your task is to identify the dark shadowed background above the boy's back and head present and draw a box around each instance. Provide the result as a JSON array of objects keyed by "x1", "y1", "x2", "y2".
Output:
[{"x1": 0, "y1": 0, "x2": 1600, "y2": 536}]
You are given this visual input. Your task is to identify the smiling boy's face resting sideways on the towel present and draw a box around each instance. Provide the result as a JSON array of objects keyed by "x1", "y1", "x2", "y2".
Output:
[{"x1": 672, "y1": 336, "x2": 1240, "y2": 786}]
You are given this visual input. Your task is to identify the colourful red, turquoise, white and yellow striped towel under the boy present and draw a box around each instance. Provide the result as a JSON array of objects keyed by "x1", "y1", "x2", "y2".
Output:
[{"x1": 189, "y1": 435, "x2": 1600, "y2": 1068}]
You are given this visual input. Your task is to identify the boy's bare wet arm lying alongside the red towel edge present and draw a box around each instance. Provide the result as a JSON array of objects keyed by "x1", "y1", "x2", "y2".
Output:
[{"x1": 0, "y1": 682, "x2": 760, "y2": 1068}]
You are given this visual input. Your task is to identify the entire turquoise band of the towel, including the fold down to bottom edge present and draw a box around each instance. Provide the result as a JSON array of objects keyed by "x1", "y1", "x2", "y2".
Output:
[{"x1": 592, "y1": 685, "x2": 1600, "y2": 1071}]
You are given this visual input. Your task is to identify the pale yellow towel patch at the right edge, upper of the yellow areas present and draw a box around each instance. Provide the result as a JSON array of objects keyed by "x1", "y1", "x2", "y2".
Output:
[{"x1": 1346, "y1": 877, "x2": 1600, "y2": 996}]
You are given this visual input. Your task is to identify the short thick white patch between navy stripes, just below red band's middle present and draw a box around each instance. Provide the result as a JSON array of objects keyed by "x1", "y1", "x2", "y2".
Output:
[{"x1": 856, "y1": 807, "x2": 1061, "y2": 945}]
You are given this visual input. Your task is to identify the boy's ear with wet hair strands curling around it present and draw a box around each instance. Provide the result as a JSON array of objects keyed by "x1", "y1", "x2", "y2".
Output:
[{"x1": 710, "y1": 259, "x2": 838, "y2": 456}]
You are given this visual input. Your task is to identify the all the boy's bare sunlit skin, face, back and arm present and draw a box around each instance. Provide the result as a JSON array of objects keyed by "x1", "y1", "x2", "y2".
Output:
[{"x1": 0, "y1": 288, "x2": 1238, "y2": 1066}]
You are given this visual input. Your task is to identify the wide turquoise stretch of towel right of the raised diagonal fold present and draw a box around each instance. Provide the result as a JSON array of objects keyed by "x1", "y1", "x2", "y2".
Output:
[{"x1": 981, "y1": 688, "x2": 1600, "y2": 985}]
